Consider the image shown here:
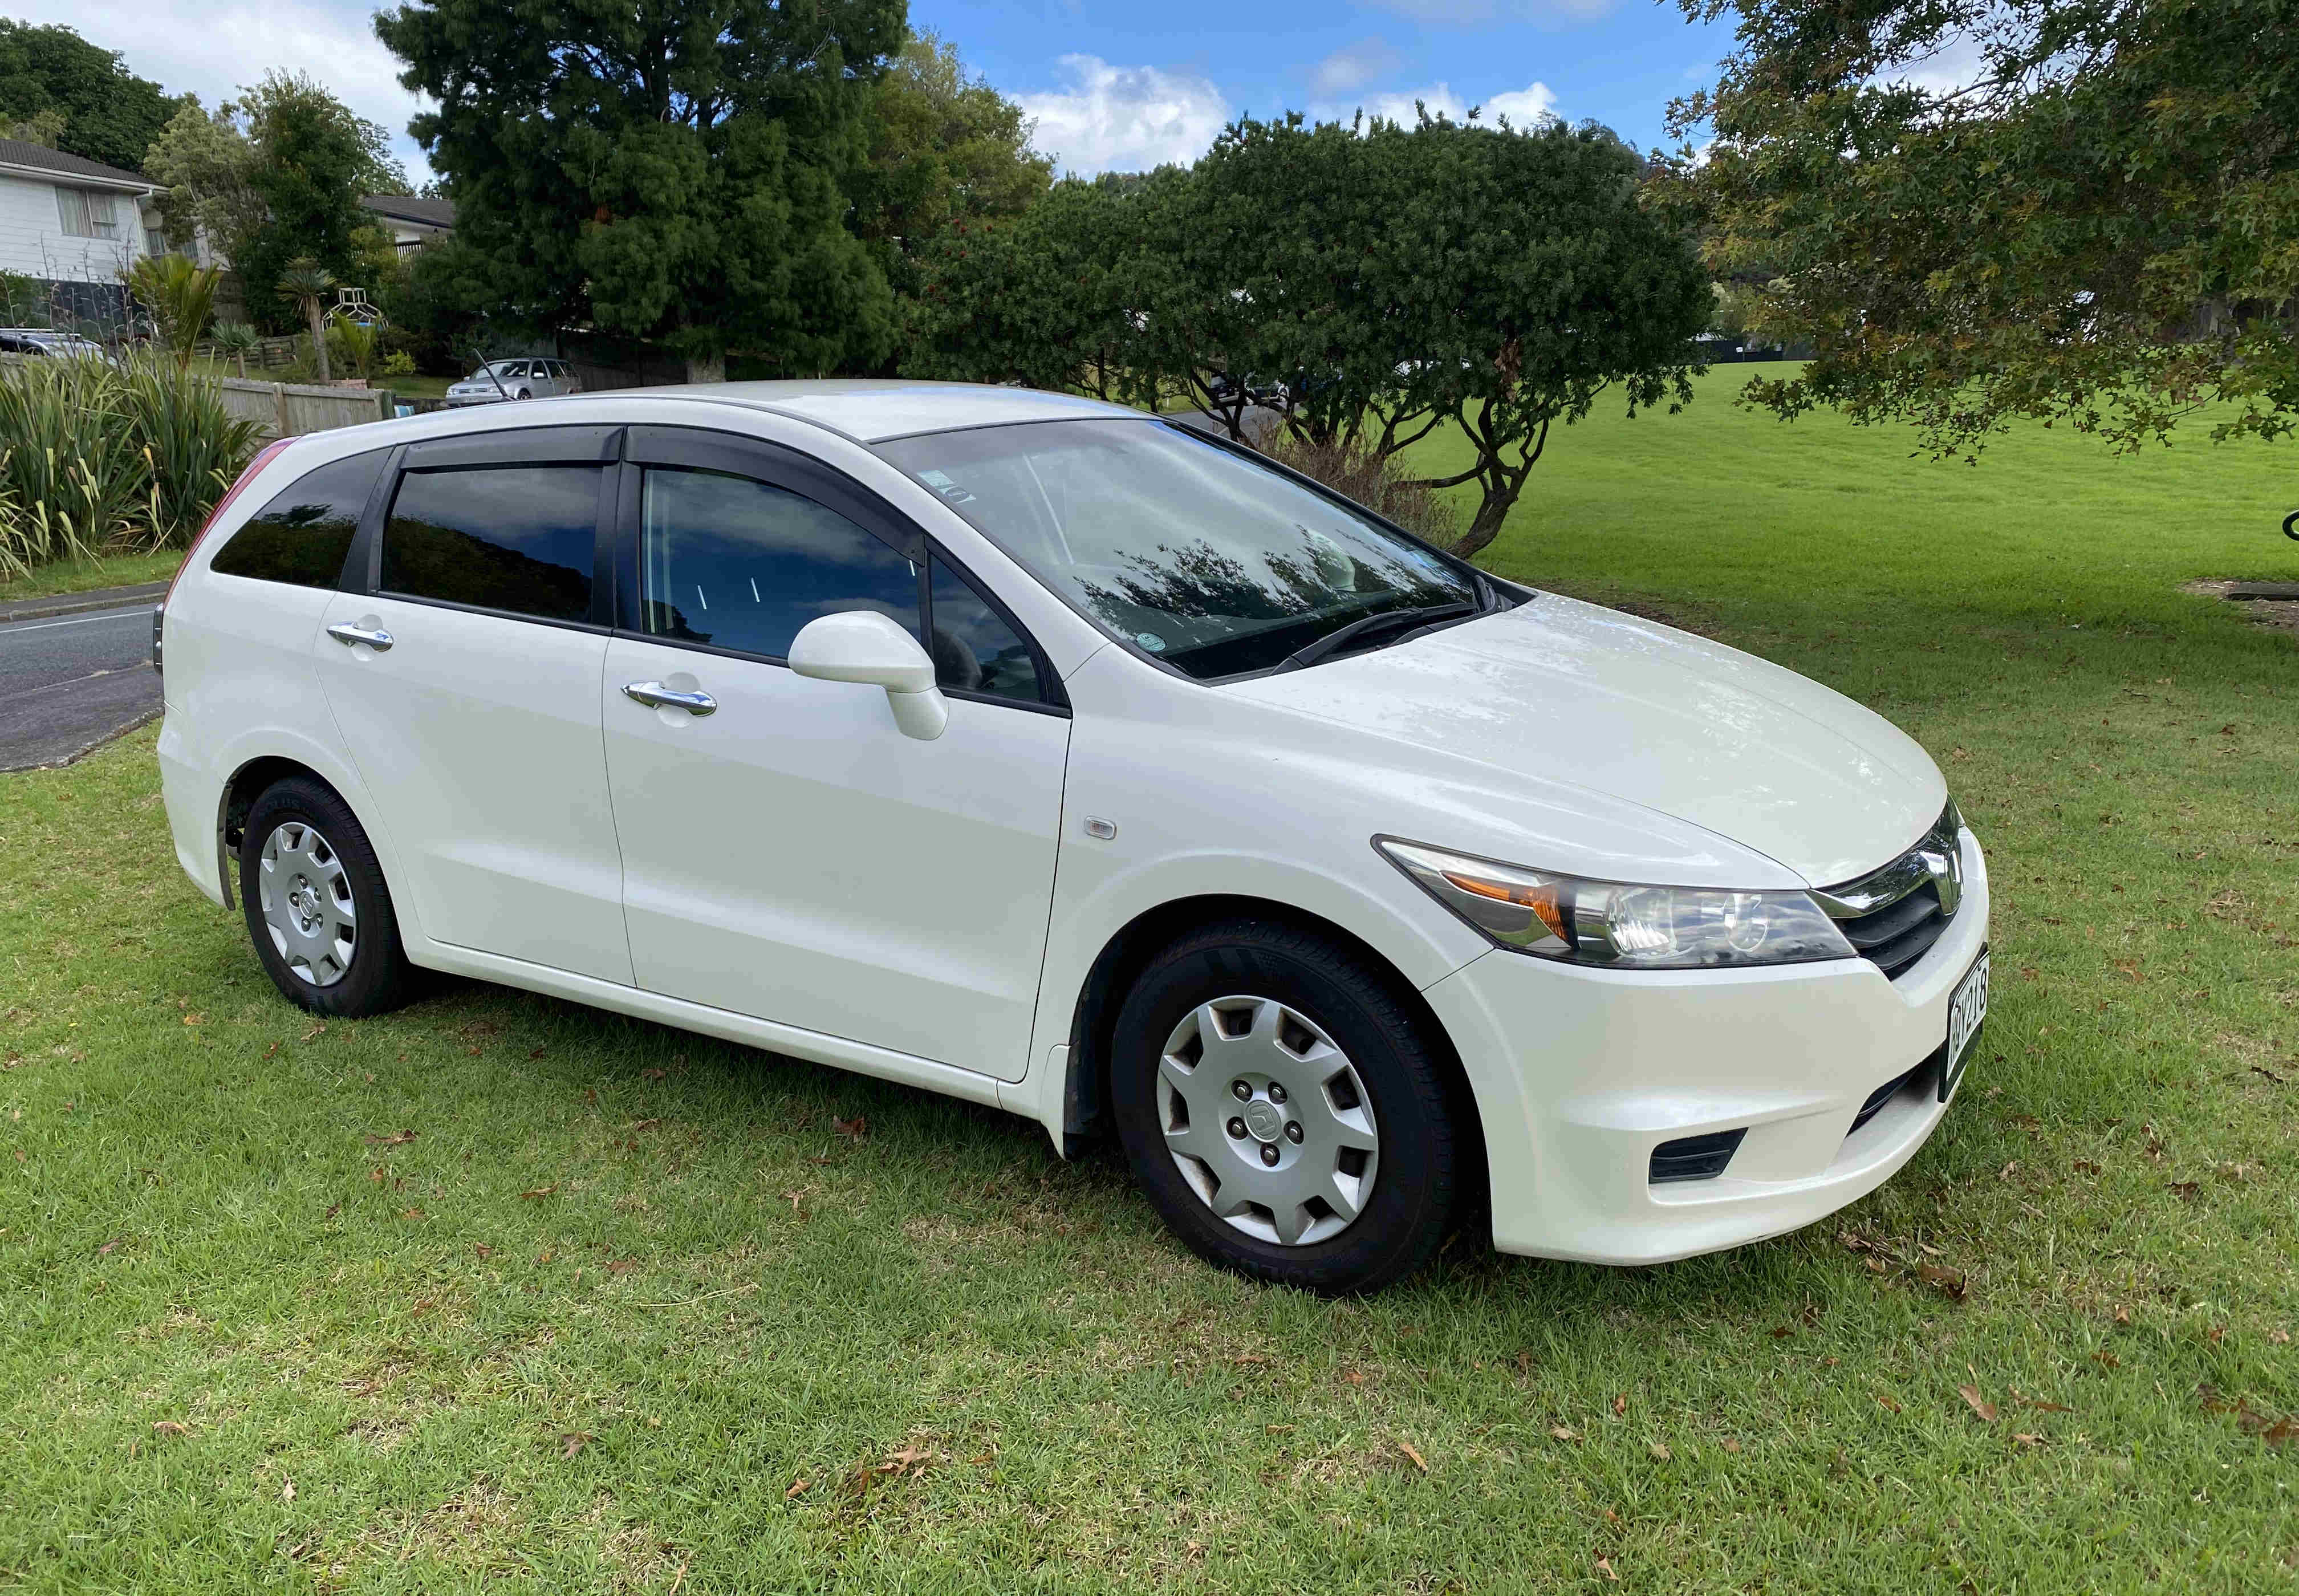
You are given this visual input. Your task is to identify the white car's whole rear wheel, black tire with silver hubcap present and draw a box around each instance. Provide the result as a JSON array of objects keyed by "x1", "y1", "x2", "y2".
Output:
[{"x1": 239, "y1": 775, "x2": 414, "y2": 1019}]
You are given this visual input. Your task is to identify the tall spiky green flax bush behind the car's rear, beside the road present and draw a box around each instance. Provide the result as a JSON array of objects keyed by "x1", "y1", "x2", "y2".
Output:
[{"x1": 0, "y1": 354, "x2": 258, "y2": 577}]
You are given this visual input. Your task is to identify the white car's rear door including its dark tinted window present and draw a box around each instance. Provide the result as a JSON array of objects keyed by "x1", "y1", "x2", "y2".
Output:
[{"x1": 312, "y1": 428, "x2": 630, "y2": 984}]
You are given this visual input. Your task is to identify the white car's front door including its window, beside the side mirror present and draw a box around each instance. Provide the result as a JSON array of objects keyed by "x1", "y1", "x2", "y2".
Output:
[{"x1": 600, "y1": 428, "x2": 1069, "y2": 1081}]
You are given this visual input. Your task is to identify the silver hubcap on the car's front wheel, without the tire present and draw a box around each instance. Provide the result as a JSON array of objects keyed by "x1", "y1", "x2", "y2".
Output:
[{"x1": 1156, "y1": 998, "x2": 1382, "y2": 1246}]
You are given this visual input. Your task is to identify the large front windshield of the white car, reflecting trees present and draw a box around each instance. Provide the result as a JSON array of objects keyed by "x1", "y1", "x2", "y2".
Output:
[{"x1": 876, "y1": 419, "x2": 1490, "y2": 679}]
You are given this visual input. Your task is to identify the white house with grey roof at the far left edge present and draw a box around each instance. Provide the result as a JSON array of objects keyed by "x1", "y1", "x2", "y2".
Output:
[{"x1": 0, "y1": 138, "x2": 168, "y2": 324}]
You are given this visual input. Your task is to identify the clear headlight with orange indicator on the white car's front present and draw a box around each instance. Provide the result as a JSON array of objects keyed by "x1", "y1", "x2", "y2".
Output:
[{"x1": 1372, "y1": 837, "x2": 1858, "y2": 970}]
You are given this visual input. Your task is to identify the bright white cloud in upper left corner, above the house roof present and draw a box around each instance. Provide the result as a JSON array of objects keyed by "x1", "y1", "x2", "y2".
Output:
[{"x1": 9, "y1": 0, "x2": 428, "y2": 182}]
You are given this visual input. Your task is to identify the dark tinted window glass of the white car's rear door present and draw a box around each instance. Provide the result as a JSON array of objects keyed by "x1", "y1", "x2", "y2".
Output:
[{"x1": 381, "y1": 465, "x2": 600, "y2": 621}]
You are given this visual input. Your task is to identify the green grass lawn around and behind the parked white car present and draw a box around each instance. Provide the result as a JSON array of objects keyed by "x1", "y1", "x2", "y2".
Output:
[{"x1": 0, "y1": 370, "x2": 2299, "y2": 1594}]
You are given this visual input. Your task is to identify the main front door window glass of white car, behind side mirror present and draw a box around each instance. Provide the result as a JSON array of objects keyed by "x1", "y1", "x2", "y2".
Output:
[{"x1": 639, "y1": 467, "x2": 917, "y2": 660}]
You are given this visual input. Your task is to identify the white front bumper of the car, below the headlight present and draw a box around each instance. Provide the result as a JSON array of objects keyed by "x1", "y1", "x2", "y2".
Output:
[{"x1": 1423, "y1": 830, "x2": 1989, "y2": 1262}]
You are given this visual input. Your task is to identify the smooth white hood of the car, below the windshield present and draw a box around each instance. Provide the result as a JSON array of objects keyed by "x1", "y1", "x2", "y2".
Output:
[{"x1": 1223, "y1": 594, "x2": 1947, "y2": 886}]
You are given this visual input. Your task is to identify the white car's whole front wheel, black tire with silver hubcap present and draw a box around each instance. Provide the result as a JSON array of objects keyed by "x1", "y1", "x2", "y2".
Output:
[{"x1": 1110, "y1": 920, "x2": 1462, "y2": 1295}]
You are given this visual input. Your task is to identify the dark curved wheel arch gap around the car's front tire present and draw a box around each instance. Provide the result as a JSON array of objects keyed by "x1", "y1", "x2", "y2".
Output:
[{"x1": 1062, "y1": 895, "x2": 1485, "y2": 1191}]
